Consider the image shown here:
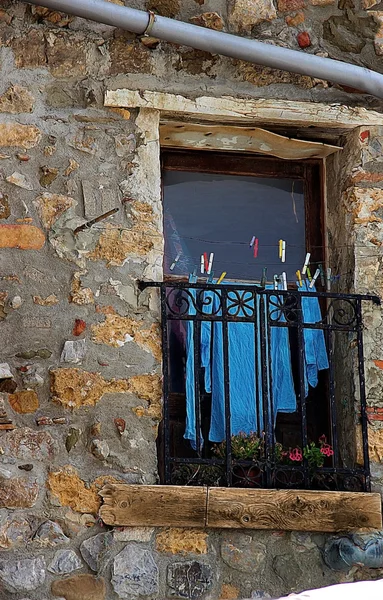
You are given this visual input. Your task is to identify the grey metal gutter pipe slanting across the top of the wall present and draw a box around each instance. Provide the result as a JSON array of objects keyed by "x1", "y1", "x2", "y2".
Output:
[{"x1": 28, "y1": 0, "x2": 383, "y2": 99}]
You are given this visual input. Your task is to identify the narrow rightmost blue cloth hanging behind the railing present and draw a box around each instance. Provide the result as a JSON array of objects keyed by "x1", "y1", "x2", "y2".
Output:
[{"x1": 298, "y1": 281, "x2": 329, "y2": 396}]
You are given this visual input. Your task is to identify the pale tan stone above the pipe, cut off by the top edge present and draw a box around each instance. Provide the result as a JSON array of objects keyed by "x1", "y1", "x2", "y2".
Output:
[{"x1": 229, "y1": 0, "x2": 277, "y2": 33}]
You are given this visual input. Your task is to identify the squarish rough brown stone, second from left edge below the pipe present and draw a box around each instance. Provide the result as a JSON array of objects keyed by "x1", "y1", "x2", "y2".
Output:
[{"x1": 47, "y1": 31, "x2": 86, "y2": 78}]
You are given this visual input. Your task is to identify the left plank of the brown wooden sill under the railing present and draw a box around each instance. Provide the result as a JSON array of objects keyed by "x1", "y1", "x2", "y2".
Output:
[{"x1": 100, "y1": 484, "x2": 207, "y2": 527}]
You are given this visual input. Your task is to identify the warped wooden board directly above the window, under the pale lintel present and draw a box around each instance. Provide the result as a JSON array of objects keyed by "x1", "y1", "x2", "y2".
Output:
[{"x1": 160, "y1": 121, "x2": 342, "y2": 160}]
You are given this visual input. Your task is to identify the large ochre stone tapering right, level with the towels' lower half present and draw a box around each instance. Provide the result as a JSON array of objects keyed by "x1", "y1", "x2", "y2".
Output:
[{"x1": 51, "y1": 369, "x2": 130, "y2": 408}]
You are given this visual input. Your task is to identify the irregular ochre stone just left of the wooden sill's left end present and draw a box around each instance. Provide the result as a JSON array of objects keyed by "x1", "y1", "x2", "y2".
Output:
[{"x1": 47, "y1": 465, "x2": 121, "y2": 514}]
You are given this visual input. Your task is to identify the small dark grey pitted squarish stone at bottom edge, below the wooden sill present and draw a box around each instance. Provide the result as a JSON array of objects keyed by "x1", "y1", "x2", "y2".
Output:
[{"x1": 167, "y1": 560, "x2": 212, "y2": 600}]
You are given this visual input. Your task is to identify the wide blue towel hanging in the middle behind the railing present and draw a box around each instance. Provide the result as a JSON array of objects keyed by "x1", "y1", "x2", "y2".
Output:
[{"x1": 209, "y1": 286, "x2": 296, "y2": 442}]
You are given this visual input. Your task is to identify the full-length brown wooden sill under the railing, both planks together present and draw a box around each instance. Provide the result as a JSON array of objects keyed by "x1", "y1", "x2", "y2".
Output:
[{"x1": 100, "y1": 484, "x2": 382, "y2": 533}]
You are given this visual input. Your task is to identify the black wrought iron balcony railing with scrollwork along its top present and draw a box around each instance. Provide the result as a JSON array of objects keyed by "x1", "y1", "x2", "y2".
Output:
[{"x1": 140, "y1": 282, "x2": 379, "y2": 491}]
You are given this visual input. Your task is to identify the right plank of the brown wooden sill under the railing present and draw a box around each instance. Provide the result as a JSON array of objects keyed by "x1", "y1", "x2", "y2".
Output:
[{"x1": 206, "y1": 488, "x2": 382, "y2": 532}]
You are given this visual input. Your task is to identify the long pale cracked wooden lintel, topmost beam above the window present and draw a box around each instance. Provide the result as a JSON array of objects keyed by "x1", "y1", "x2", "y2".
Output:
[{"x1": 104, "y1": 89, "x2": 383, "y2": 129}]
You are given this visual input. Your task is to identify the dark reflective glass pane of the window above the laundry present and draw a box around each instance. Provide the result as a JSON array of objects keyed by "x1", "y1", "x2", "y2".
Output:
[{"x1": 163, "y1": 170, "x2": 306, "y2": 281}]
